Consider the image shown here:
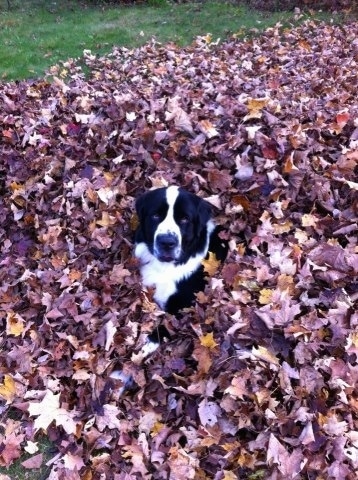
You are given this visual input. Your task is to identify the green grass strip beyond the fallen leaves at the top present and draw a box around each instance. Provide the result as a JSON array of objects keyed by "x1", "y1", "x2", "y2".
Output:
[{"x1": 0, "y1": 0, "x2": 340, "y2": 80}]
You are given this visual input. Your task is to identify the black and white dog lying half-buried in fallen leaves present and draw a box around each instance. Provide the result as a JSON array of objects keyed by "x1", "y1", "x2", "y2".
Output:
[{"x1": 110, "y1": 186, "x2": 228, "y2": 394}]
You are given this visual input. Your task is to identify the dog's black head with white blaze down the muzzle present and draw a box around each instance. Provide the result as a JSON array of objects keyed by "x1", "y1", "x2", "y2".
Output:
[{"x1": 136, "y1": 186, "x2": 211, "y2": 263}]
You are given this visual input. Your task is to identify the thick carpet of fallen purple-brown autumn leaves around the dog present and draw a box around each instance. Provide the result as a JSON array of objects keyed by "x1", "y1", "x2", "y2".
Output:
[{"x1": 0, "y1": 19, "x2": 358, "y2": 480}]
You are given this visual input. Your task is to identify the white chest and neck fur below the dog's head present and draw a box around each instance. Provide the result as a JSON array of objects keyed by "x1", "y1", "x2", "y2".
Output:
[{"x1": 134, "y1": 220, "x2": 215, "y2": 309}]
